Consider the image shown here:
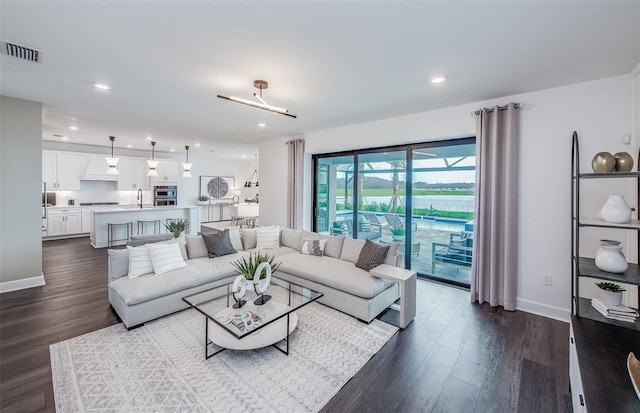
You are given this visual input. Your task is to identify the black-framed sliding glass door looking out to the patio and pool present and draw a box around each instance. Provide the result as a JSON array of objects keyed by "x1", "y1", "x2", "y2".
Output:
[{"x1": 314, "y1": 138, "x2": 475, "y2": 286}]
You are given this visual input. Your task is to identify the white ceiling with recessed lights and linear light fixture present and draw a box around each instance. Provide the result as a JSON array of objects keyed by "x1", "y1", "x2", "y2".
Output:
[{"x1": 0, "y1": 0, "x2": 640, "y2": 156}]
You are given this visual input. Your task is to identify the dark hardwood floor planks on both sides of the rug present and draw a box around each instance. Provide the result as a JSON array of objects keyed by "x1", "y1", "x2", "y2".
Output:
[{"x1": 0, "y1": 238, "x2": 571, "y2": 412}]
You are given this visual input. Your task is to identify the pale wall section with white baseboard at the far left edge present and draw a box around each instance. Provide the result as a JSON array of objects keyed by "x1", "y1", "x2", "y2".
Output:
[{"x1": 0, "y1": 96, "x2": 43, "y2": 291}]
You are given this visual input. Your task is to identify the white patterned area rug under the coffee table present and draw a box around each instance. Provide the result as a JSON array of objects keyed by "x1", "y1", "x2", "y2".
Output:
[{"x1": 50, "y1": 303, "x2": 398, "y2": 412}]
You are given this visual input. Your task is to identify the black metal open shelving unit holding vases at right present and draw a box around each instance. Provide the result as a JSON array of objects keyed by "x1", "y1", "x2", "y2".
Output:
[{"x1": 571, "y1": 132, "x2": 640, "y2": 330}]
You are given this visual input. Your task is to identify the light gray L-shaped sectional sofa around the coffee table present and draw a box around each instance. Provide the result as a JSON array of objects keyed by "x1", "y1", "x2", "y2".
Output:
[{"x1": 108, "y1": 228, "x2": 402, "y2": 328}]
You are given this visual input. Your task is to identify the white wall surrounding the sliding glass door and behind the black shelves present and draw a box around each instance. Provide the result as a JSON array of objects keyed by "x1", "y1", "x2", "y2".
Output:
[{"x1": 260, "y1": 75, "x2": 639, "y2": 320}]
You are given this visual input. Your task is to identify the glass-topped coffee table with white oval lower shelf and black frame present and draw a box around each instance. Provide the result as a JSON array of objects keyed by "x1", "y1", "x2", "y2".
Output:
[{"x1": 182, "y1": 273, "x2": 324, "y2": 359}]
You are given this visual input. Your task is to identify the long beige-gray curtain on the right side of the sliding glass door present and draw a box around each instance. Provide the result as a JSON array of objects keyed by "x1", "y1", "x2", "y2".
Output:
[{"x1": 471, "y1": 103, "x2": 519, "y2": 311}]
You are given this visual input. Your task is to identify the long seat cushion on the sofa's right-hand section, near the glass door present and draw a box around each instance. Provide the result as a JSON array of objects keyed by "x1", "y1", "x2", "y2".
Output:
[{"x1": 278, "y1": 254, "x2": 393, "y2": 299}]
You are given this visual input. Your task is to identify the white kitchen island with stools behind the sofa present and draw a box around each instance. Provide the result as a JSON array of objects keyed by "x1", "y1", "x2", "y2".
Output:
[{"x1": 90, "y1": 205, "x2": 200, "y2": 248}]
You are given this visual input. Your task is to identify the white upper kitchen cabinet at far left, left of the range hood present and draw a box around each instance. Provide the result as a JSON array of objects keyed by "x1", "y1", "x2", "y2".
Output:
[{"x1": 42, "y1": 152, "x2": 82, "y2": 191}]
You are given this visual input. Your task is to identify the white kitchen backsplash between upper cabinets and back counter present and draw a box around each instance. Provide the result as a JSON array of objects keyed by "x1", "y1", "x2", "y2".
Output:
[{"x1": 56, "y1": 181, "x2": 153, "y2": 206}]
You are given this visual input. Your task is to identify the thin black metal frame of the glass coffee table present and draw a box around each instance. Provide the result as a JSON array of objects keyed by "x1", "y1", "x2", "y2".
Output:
[{"x1": 182, "y1": 276, "x2": 324, "y2": 360}]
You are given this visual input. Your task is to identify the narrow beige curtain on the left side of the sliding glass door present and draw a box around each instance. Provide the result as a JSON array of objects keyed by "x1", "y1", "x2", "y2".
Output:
[{"x1": 287, "y1": 139, "x2": 304, "y2": 229}]
